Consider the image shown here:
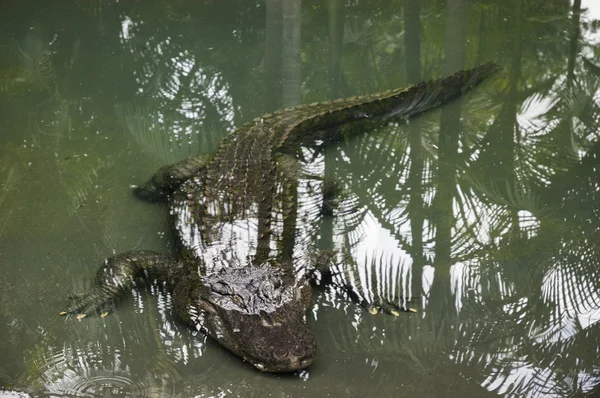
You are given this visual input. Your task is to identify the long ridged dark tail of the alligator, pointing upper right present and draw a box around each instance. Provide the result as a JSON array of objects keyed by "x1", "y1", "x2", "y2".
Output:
[{"x1": 277, "y1": 62, "x2": 500, "y2": 151}]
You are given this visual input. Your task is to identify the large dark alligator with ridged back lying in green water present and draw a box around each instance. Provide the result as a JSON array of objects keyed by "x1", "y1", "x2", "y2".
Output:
[{"x1": 61, "y1": 63, "x2": 498, "y2": 372}]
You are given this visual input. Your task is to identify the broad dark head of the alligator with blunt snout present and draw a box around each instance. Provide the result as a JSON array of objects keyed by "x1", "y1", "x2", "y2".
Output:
[{"x1": 173, "y1": 262, "x2": 317, "y2": 372}]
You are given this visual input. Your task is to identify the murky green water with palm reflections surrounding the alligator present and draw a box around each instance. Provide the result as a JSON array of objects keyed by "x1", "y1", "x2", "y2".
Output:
[{"x1": 0, "y1": 0, "x2": 600, "y2": 397}]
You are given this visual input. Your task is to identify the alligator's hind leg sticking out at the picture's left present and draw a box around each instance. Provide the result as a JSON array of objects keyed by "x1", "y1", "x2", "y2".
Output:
[{"x1": 133, "y1": 154, "x2": 211, "y2": 202}]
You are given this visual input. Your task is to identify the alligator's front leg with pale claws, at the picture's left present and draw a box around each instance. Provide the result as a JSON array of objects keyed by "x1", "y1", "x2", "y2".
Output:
[{"x1": 60, "y1": 250, "x2": 183, "y2": 319}]
